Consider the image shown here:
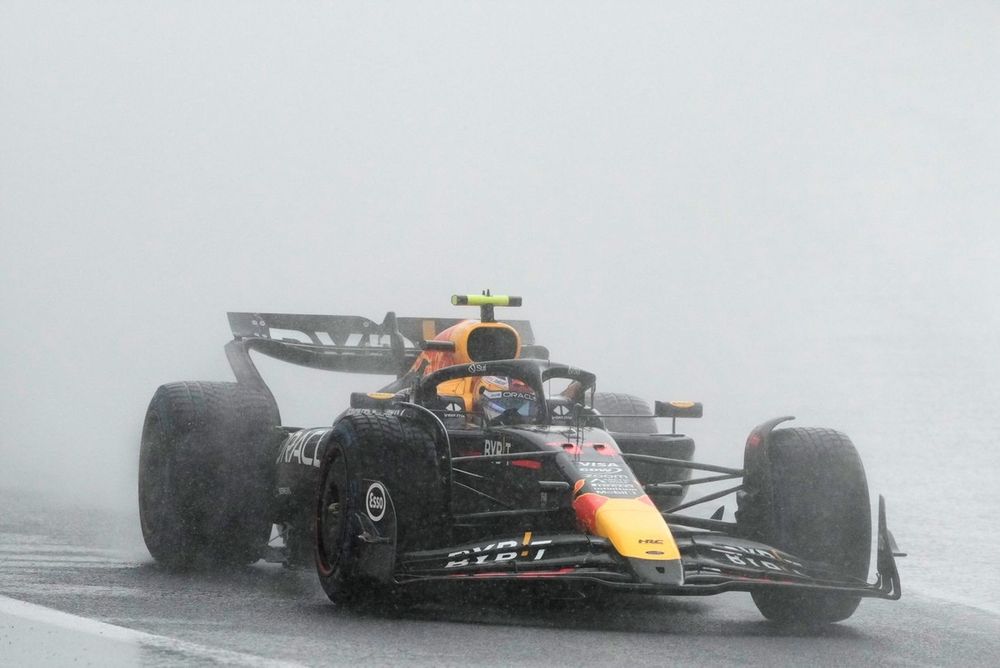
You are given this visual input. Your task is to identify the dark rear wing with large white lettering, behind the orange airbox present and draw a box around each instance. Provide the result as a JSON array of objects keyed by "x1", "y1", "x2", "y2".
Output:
[{"x1": 226, "y1": 311, "x2": 535, "y2": 386}]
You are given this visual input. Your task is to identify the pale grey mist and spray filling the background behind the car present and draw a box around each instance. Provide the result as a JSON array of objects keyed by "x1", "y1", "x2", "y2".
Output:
[{"x1": 0, "y1": 1, "x2": 1000, "y2": 605}]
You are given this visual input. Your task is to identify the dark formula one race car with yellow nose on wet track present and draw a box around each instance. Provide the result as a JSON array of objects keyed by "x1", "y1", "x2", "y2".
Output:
[{"x1": 139, "y1": 292, "x2": 900, "y2": 624}]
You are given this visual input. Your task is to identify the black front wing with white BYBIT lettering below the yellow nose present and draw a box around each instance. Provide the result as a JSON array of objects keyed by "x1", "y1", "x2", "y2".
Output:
[{"x1": 394, "y1": 498, "x2": 901, "y2": 599}]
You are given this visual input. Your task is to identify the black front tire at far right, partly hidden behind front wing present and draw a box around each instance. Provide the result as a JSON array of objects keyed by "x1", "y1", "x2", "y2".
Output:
[{"x1": 736, "y1": 428, "x2": 871, "y2": 626}]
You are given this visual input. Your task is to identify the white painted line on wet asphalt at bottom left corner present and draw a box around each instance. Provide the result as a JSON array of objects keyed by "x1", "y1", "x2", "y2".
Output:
[{"x1": 0, "y1": 596, "x2": 303, "y2": 668}]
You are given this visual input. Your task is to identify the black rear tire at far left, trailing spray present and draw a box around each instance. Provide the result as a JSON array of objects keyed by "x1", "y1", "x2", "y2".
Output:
[{"x1": 139, "y1": 382, "x2": 280, "y2": 568}]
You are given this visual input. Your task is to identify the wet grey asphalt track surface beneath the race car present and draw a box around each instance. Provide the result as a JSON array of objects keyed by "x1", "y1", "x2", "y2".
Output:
[{"x1": 0, "y1": 491, "x2": 1000, "y2": 668}]
